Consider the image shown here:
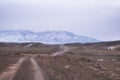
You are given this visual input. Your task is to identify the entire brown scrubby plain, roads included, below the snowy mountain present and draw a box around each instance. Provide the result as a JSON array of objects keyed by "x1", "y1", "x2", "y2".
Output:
[{"x1": 0, "y1": 41, "x2": 120, "y2": 80}]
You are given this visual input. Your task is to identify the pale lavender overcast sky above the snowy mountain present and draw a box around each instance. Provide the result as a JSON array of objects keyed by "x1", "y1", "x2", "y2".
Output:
[{"x1": 0, "y1": 0, "x2": 120, "y2": 40}]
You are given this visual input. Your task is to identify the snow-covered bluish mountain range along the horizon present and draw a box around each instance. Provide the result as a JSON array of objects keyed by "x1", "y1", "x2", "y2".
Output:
[{"x1": 0, "y1": 30, "x2": 98, "y2": 44}]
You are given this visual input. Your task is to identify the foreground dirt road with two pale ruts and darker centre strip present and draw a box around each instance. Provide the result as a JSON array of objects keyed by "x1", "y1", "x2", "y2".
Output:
[{"x1": 0, "y1": 57, "x2": 45, "y2": 80}]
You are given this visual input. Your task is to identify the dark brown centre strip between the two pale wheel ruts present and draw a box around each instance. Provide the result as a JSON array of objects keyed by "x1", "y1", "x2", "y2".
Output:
[{"x1": 13, "y1": 56, "x2": 34, "y2": 80}]
